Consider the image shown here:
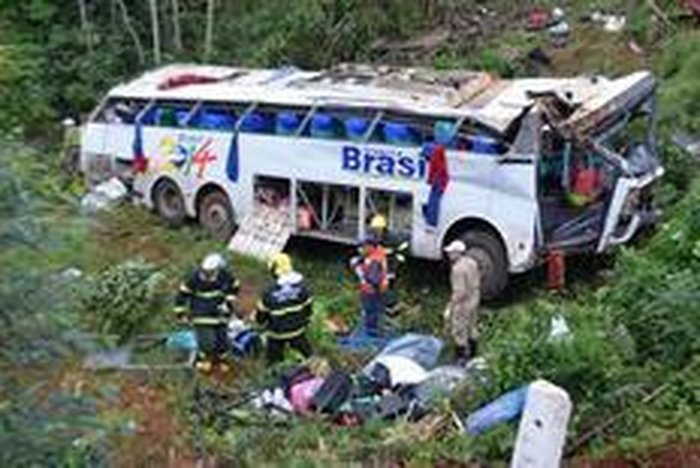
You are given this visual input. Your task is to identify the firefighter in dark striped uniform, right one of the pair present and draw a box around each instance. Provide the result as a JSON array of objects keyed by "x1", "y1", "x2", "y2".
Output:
[{"x1": 255, "y1": 253, "x2": 314, "y2": 364}]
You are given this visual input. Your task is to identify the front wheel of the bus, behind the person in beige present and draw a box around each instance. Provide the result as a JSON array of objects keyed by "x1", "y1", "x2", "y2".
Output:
[{"x1": 460, "y1": 229, "x2": 508, "y2": 300}]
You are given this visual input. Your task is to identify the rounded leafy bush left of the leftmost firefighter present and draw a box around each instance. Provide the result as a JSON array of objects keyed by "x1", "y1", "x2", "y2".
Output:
[{"x1": 82, "y1": 260, "x2": 166, "y2": 341}]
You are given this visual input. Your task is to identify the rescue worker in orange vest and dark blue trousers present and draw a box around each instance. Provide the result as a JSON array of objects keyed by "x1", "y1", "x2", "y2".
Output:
[{"x1": 351, "y1": 236, "x2": 389, "y2": 337}]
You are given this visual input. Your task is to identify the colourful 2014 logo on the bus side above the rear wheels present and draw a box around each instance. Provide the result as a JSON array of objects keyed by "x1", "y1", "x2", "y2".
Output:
[{"x1": 154, "y1": 134, "x2": 218, "y2": 179}]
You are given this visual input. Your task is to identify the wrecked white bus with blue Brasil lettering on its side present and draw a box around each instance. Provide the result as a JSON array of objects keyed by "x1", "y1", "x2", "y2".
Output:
[{"x1": 81, "y1": 65, "x2": 663, "y2": 297}]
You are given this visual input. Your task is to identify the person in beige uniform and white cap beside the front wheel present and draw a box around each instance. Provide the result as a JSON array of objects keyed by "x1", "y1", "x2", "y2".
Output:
[{"x1": 445, "y1": 240, "x2": 481, "y2": 364}]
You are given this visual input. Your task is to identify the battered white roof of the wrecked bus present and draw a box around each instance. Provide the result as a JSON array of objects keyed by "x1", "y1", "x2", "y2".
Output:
[{"x1": 109, "y1": 64, "x2": 650, "y2": 132}]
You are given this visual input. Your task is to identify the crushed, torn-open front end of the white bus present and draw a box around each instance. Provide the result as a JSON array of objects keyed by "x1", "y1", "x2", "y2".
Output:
[{"x1": 533, "y1": 72, "x2": 664, "y2": 253}]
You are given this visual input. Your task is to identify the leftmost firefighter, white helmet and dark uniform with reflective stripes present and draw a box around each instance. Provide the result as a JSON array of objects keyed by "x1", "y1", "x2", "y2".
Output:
[{"x1": 175, "y1": 253, "x2": 240, "y2": 372}]
